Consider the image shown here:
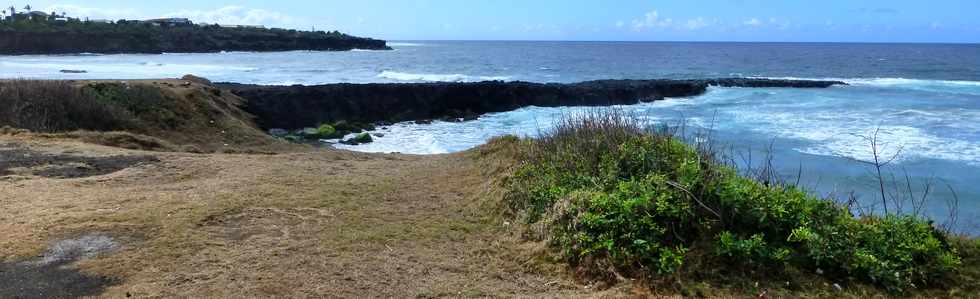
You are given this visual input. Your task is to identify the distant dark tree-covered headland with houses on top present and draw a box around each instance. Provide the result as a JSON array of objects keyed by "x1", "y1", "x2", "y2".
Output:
[{"x1": 0, "y1": 6, "x2": 391, "y2": 55}]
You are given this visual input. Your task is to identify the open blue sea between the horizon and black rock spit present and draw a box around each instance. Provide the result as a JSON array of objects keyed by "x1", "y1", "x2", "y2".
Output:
[{"x1": 0, "y1": 41, "x2": 980, "y2": 84}]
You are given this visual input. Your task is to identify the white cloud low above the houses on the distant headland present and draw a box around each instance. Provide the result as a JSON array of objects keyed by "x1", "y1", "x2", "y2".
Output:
[{"x1": 163, "y1": 5, "x2": 299, "y2": 27}]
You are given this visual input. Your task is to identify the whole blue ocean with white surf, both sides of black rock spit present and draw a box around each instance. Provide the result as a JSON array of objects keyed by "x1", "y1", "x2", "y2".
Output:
[{"x1": 0, "y1": 41, "x2": 980, "y2": 235}]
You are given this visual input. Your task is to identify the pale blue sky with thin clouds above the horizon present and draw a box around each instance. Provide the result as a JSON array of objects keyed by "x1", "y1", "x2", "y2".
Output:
[{"x1": 4, "y1": 0, "x2": 980, "y2": 43}]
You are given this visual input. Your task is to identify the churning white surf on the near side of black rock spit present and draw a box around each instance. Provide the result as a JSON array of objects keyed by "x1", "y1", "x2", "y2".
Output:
[{"x1": 338, "y1": 88, "x2": 980, "y2": 165}]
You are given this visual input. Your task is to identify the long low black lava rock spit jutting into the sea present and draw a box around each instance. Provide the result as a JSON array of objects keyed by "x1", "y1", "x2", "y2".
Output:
[{"x1": 218, "y1": 78, "x2": 845, "y2": 129}]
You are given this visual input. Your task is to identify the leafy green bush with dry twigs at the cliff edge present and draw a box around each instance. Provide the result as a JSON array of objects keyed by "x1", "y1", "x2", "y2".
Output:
[{"x1": 507, "y1": 110, "x2": 961, "y2": 292}]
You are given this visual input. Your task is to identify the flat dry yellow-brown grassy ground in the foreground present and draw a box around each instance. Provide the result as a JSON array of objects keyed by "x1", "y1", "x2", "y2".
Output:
[{"x1": 0, "y1": 137, "x2": 622, "y2": 298}]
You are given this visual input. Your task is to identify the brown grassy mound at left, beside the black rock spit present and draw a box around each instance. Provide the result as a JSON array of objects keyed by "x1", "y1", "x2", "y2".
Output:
[{"x1": 0, "y1": 76, "x2": 290, "y2": 154}]
